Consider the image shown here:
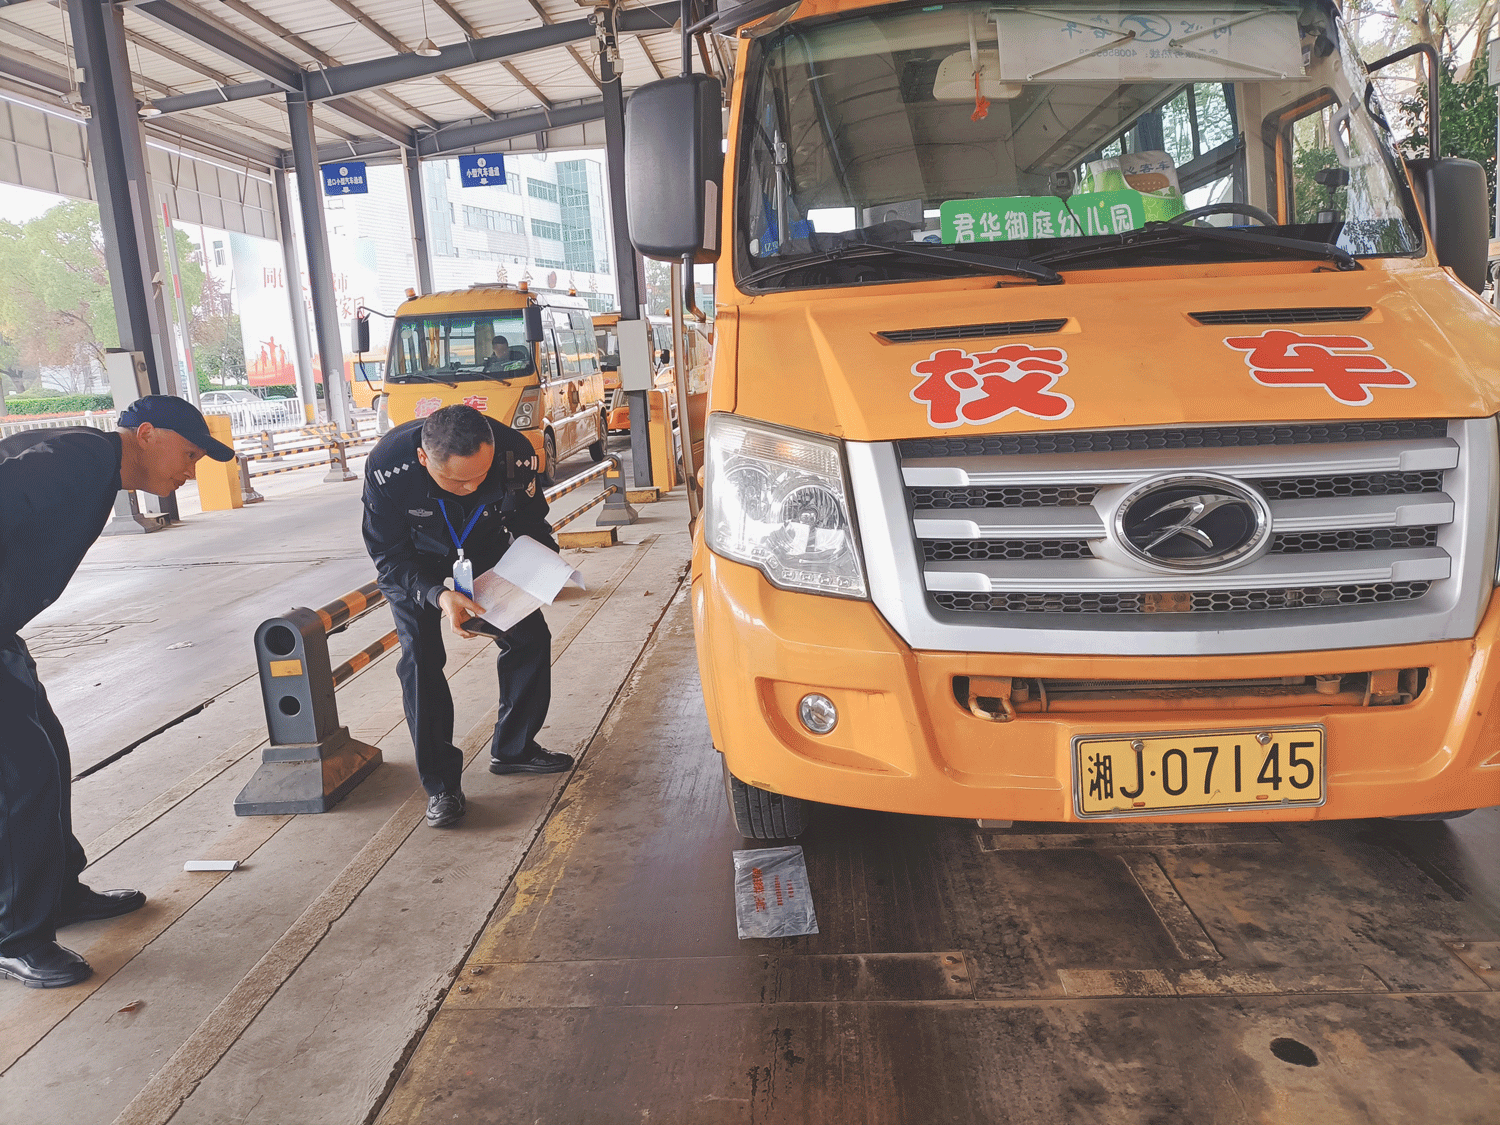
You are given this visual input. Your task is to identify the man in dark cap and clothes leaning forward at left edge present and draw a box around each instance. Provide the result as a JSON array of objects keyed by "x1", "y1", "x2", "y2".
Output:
[{"x1": 0, "y1": 395, "x2": 234, "y2": 989}]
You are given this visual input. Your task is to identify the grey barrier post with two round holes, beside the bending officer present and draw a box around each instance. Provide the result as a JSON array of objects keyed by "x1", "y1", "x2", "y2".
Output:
[{"x1": 234, "y1": 608, "x2": 381, "y2": 816}]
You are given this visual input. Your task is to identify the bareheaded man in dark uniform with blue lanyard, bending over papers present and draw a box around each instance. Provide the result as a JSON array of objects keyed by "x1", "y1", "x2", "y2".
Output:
[{"x1": 365, "y1": 407, "x2": 573, "y2": 828}]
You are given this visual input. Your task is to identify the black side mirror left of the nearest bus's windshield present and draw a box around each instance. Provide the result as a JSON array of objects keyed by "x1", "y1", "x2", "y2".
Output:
[{"x1": 626, "y1": 74, "x2": 725, "y2": 261}]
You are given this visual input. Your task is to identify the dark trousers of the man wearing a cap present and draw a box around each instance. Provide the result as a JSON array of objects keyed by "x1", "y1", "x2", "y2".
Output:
[{"x1": 0, "y1": 636, "x2": 84, "y2": 957}]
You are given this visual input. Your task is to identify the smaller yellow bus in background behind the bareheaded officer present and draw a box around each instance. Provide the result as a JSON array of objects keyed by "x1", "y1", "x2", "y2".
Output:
[{"x1": 384, "y1": 282, "x2": 605, "y2": 476}]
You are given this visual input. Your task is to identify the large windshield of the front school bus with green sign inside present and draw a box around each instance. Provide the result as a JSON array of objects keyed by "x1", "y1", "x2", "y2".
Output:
[{"x1": 735, "y1": 0, "x2": 1422, "y2": 291}]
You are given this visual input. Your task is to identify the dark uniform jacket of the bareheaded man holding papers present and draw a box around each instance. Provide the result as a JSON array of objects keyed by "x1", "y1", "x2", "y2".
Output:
[{"x1": 365, "y1": 417, "x2": 557, "y2": 606}]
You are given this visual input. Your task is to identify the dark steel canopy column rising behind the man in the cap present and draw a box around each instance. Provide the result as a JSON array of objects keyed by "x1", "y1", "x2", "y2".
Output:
[{"x1": 68, "y1": 0, "x2": 179, "y2": 408}]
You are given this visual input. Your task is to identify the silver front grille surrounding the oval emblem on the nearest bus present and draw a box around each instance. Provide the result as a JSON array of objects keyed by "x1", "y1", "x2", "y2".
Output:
[{"x1": 849, "y1": 419, "x2": 1497, "y2": 654}]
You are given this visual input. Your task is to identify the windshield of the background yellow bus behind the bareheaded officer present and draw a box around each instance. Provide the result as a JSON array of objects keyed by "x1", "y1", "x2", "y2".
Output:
[{"x1": 389, "y1": 309, "x2": 536, "y2": 383}]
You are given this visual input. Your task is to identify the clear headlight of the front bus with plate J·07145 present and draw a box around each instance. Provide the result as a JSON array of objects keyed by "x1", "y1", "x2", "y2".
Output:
[{"x1": 704, "y1": 414, "x2": 866, "y2": 597}]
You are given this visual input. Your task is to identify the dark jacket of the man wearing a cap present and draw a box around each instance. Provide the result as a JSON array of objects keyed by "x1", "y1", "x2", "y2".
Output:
[{"x1": 0, "y1": 426, "x2": 120, "y2": 639}]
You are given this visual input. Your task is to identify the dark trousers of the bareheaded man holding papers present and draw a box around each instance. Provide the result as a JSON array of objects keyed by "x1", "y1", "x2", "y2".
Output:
[{"x1": 390, "y1": 602, "x2": 552, "y2": 797}]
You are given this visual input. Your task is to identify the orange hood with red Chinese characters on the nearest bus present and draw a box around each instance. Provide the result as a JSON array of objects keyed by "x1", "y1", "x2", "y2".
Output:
[{"x1": 729, "y1": 261, "x2": 1500, "y2": 441}]
